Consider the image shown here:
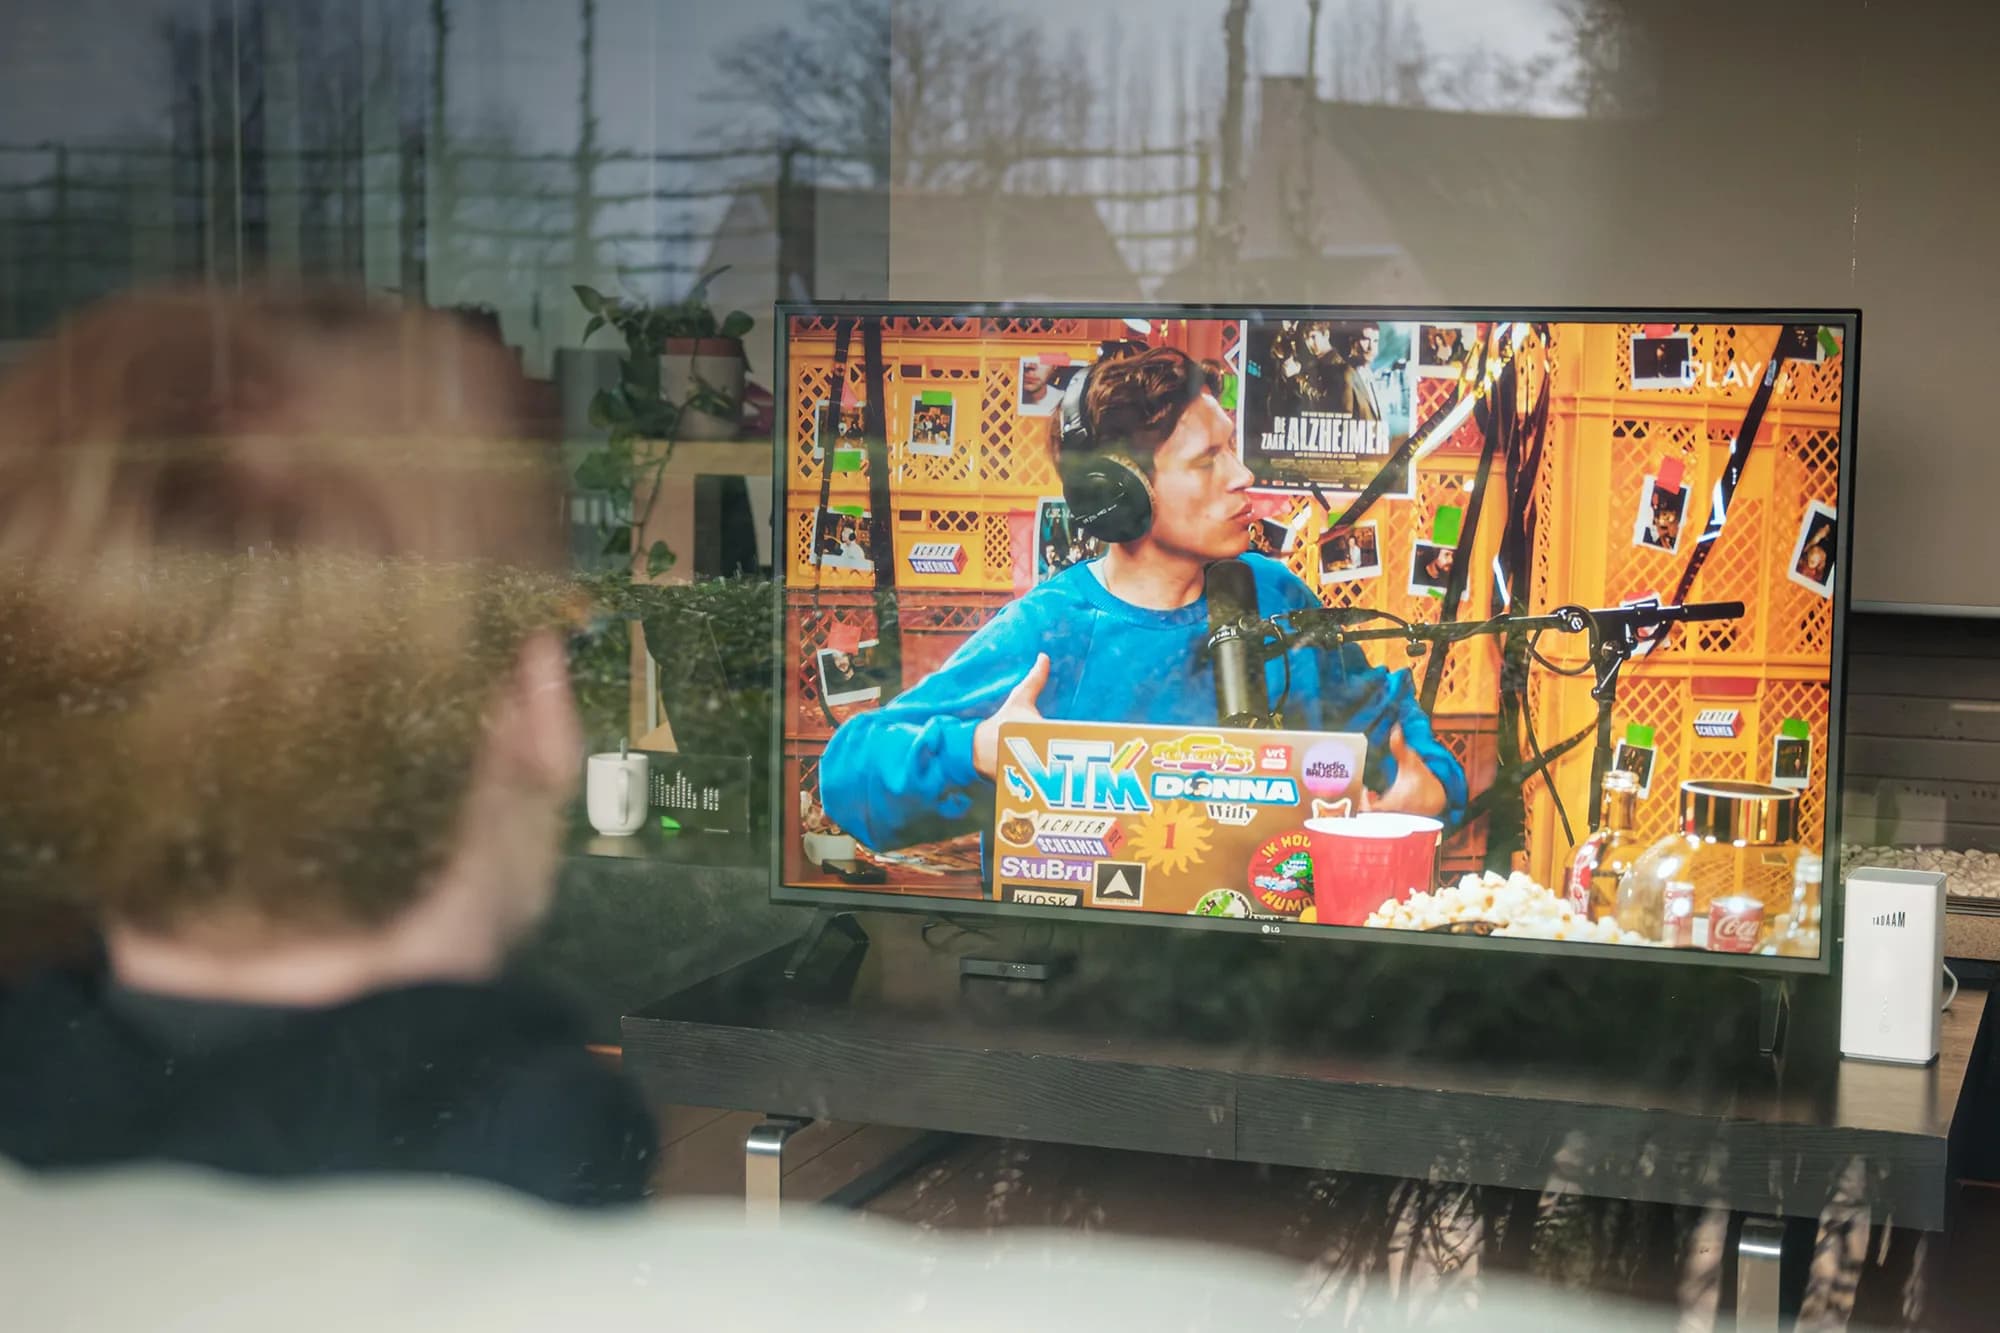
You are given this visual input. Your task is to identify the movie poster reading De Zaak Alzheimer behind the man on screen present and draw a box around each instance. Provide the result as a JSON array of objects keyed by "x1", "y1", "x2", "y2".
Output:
[{"x1": 1242, "y1": 320, "x2": 1416, "y2": 496}]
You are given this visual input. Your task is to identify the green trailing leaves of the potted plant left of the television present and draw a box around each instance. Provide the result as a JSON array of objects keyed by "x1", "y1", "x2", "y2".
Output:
[{"x1": 572, "y1": 266, "x2": 756, "y2": 576}]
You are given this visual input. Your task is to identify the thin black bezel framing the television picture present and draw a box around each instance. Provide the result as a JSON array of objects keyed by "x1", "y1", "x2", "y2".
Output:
[{"x1": 770, "y1": 300, "x2": 1862, "y2": 977}]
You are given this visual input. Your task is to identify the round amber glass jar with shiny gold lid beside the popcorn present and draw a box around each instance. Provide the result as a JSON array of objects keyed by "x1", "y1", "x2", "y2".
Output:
[{"x1": 1618, "y1": 781, "x2": 1818, "y2": 939}]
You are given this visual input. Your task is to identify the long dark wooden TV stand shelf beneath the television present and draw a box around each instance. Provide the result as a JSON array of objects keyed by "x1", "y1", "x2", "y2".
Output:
[{"x1": 624, "y1": 913, "x2": 1986, "y2": 1229}]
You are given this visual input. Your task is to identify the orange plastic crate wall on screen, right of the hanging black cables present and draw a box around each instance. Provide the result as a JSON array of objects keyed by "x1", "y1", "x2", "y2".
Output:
[{"x1": 1528, "y1": 324, "x2": 1840, "y2": 883}]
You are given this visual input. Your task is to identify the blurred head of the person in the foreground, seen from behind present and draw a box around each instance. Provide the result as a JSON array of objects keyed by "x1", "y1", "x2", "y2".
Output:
[{"x1": 0, "y1": 288, "x2": 582, "y2": 1003}]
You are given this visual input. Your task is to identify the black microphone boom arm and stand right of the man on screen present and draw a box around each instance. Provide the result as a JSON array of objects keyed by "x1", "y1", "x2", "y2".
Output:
[{"x1": 1210, "y1": 602, "x2": 1744, "y2": 833}]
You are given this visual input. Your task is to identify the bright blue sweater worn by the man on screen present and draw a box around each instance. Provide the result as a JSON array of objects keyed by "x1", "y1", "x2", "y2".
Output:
[{"x1": 820, "y1": 554, "x2": 1466, "y2": 851}]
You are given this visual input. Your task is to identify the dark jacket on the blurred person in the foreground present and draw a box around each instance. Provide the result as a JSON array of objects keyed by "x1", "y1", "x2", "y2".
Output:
[{"x1": 0, "y1": 975, "x2": 658, "y2": 1205}]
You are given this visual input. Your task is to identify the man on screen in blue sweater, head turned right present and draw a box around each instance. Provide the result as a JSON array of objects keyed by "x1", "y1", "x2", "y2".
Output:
[{"x1": 820, "y1": 348, "x2": 1466, "y2": 851}]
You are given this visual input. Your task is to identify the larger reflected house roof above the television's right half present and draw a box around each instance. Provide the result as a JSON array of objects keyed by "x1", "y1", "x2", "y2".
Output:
[{"x1": 1164, "y1": 71, "x2": 1856, "y2": 306}]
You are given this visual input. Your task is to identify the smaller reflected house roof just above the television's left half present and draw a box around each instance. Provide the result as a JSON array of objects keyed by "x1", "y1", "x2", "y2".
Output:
[{"x1": 702, "y1": 186, "x2": 1140, "y2": 314}]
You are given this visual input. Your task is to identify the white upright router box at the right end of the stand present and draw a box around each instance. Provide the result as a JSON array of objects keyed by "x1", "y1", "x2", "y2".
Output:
[{"x1": 1840, "y1": 869, "x2": 1944, "y2": 1065}]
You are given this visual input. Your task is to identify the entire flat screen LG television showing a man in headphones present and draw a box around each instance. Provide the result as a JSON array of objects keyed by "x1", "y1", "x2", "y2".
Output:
[{"x1": 772, "y1": 302, "x2": 1860, "y2": 973}]
